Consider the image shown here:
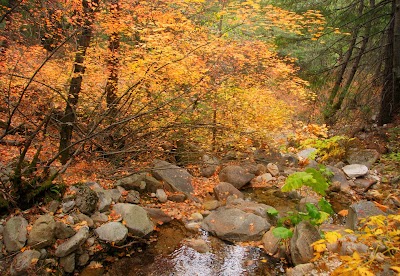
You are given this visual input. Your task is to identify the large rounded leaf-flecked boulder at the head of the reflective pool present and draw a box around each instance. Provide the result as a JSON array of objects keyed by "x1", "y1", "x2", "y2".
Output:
[{"x1": 201, "y1": 207, "x2": 271, "y2": 241}]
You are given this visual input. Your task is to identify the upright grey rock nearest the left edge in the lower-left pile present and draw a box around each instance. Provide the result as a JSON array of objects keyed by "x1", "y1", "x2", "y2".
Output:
[{"x1": 3, "y1": 216, "x2": 28, "y2": 252}]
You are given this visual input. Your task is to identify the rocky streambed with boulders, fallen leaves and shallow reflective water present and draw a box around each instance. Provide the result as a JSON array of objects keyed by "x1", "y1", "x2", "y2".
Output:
[{"x1": 0, "y1": 150, "x2": 399, "y2": 275}]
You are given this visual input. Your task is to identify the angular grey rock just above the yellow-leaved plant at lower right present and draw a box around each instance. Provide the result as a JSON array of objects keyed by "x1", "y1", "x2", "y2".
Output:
[{"x1": 346, "y1": 201, "x2": 386, "y2": 230}]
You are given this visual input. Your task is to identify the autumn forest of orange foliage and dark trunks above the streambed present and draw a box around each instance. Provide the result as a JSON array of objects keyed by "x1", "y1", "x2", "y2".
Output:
[{"x1": 0, "y1": 0, "x2": 400, "y2": 210}]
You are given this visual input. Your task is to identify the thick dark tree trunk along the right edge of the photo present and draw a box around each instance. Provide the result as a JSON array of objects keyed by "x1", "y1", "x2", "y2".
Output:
[{"x1": 378, "y1": 0, "x2": 400, "y2": 125}]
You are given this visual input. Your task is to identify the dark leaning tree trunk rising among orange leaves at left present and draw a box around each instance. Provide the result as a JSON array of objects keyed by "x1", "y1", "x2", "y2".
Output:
[{"x1": 59, "y1": 0, "x2": 98, "y2": 164}]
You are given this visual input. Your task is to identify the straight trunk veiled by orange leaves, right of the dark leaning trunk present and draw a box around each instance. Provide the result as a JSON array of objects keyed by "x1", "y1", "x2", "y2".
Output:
[{"x1": 106, "y1": 0, "x2": 120, "y2": 113}]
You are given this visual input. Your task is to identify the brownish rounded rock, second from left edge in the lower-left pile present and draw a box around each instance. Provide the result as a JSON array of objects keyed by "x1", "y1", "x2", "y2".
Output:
[{"x1": 28, "y1": 215, "x2": 56, "y2": 249}]
